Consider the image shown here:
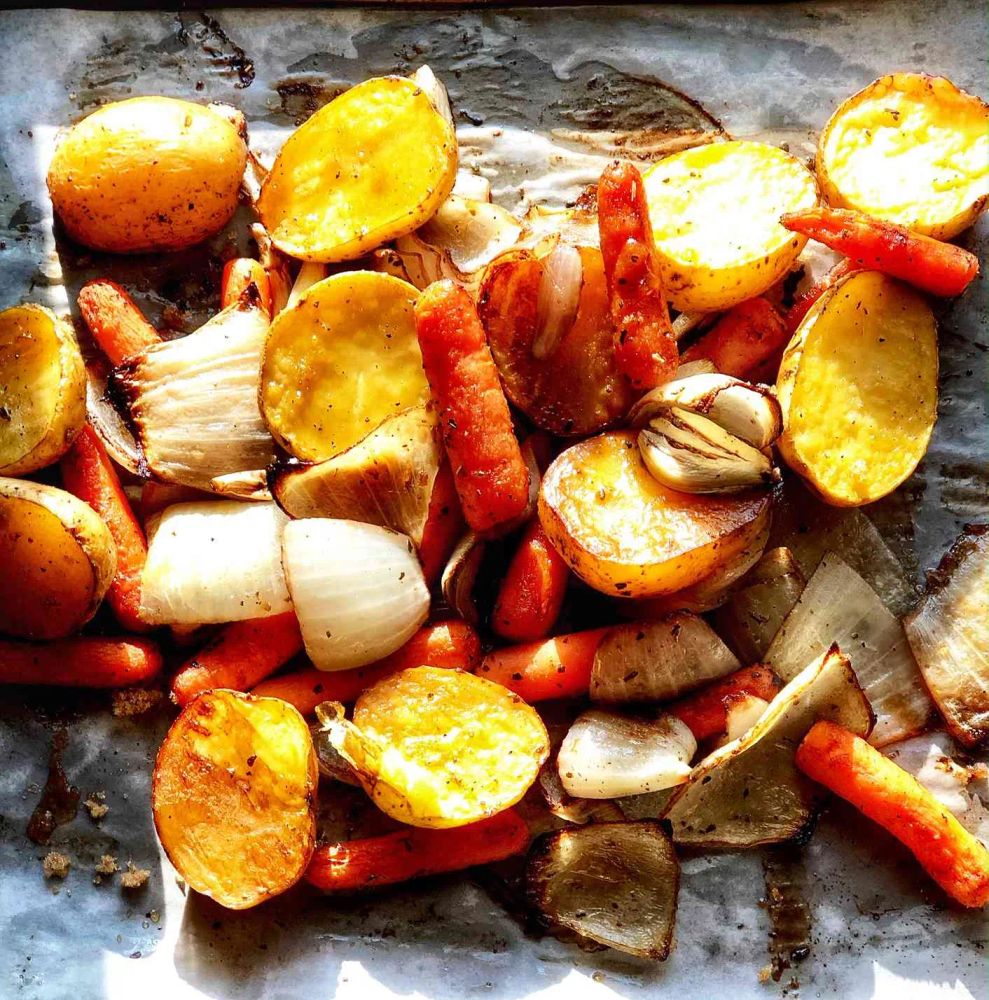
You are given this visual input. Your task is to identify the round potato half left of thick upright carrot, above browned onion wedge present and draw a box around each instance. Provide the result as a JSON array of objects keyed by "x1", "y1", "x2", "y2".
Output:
[{"x1": 260, "y1": 271, "x2": 430, "y2": 462}]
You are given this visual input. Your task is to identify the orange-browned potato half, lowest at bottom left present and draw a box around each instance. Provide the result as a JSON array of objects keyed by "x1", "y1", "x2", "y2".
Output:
[{"x1": 151, "y1": 689, "x2": 319, "y2": 910}]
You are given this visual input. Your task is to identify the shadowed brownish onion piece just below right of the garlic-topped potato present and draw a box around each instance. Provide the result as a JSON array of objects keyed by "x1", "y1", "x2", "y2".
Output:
[{"x1": 714, "y1": 546, "x2": 805, "y2": 663}]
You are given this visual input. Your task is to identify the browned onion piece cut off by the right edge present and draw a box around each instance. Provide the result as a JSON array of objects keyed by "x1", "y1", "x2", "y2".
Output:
[{"x1": 904, "y1": 524, "x2": 989, "y2": 746}]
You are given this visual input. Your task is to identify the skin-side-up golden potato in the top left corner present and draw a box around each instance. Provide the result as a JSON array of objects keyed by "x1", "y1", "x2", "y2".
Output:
[{"x1": 48, "y1": 97, "x2": 247, "y2": 253}]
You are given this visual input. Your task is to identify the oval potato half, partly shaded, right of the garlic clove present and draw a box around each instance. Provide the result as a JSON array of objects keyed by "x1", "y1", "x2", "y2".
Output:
[{"x1": 776, "y1": 271, "x2": 938, "y2": 507}]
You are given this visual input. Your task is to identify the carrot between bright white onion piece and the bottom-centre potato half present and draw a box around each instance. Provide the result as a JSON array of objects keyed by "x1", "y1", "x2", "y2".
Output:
[{"x1": 253, "y1": 620, "x2": 481, "y2": 715}]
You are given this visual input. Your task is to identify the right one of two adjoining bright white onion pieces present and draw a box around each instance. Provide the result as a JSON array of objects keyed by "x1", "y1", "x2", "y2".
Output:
[{"x1": 282, "y1": 518, "x2": 429, "y2": 670}]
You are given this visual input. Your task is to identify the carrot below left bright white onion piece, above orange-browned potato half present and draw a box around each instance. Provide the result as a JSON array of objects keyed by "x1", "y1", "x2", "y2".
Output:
[{"x1": 172, "y1": 611, "x2": 302, "y2": 705}]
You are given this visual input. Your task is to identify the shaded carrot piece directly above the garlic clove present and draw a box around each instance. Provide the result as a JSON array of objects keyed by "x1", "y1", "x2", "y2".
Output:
[{"x1": 681, "y1": 298, "x2": 790, "y2": 379}]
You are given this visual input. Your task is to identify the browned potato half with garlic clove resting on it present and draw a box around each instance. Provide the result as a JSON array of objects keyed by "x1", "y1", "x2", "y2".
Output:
[{"x1": 539, "y1": 431, "x2": 771, "y2": 597}]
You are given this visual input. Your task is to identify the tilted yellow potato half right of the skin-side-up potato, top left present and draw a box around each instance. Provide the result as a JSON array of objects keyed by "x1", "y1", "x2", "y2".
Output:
[{"x1": 257, "y1": 76, "x2": 457, "y2": 262}]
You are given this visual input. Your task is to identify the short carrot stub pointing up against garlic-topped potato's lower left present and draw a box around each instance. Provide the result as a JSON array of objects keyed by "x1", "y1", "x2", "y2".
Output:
[{"x1": 491, "y1": 518, "x2": 570, "y2": 642}]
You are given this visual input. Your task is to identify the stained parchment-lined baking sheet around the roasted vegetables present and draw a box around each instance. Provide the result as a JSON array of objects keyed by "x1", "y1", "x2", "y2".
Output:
[{"x1": 0, "y1": 0, "x2": 989, "y2": 1000}]
